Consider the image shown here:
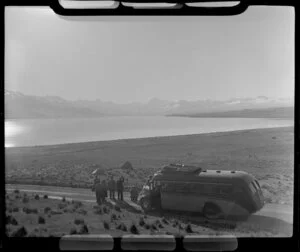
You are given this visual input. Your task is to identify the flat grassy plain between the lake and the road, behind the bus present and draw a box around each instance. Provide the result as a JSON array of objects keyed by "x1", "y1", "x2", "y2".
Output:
[{"x1": 5, "y1": 127, "x2": 294, "y2": 204}]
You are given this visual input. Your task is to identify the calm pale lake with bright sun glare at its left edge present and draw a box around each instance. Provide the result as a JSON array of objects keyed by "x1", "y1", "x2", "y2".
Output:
[{"x1": 5, "y1": 116, "x2": 294, "y2": 147}]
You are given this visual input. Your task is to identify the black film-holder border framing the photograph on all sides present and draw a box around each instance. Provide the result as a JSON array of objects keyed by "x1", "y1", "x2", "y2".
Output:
[{"x1": 0, "y1": 0, "x2": 300, "y2": 251}]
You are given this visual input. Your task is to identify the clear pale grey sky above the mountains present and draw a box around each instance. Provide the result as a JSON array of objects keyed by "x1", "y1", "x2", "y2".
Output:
[{"x1": 5, "y1": 6, "x2": 295, "y2": 103}]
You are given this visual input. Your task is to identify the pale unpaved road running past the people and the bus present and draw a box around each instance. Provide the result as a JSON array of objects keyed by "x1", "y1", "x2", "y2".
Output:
[{"x1": 6, "y1": 184, "x2": 293, "y2": 234}]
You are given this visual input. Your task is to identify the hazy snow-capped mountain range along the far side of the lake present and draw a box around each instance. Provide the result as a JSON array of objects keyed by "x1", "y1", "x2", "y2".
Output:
[{"x1": 5, "y1": 90, "x2": 293, "y2": 119}]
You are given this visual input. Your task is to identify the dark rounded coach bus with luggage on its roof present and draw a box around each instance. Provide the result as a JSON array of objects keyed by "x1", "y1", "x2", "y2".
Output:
[{"x1": 138, "y1": 164, "x2": 264, "y2": 219}]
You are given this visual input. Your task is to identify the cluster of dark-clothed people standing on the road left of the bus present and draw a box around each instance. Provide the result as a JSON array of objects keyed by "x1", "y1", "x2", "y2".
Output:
[{"x1": 94, "y1": 176, "x2": 124, "y2": 204}]
